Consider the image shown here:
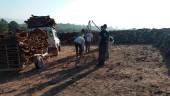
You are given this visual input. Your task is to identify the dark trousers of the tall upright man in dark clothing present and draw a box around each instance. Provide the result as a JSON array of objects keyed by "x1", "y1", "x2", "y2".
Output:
[{"x1": 98, "y1": 43, "x2": 109, "y2": 65}]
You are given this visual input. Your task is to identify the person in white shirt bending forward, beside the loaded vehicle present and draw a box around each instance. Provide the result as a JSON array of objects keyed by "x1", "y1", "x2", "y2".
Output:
[{"x1": 74, "y1": 35, "x2": 85, "y2": 58}]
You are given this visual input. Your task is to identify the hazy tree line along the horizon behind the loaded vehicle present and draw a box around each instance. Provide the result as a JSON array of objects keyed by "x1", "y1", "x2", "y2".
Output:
[{"x1": 0, "y1": 19, "x2": 96, "y2": 33}]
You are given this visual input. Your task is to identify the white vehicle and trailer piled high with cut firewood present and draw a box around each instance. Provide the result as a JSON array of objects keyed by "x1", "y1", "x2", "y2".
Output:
[{"x1": 0, "y1": 16, "x2": 60, "y2": 71}]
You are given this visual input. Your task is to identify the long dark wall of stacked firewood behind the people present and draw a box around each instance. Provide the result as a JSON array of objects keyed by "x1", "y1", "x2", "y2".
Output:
[{"x1": 59, "y1": 28, "x2": 170, "y2": 56}]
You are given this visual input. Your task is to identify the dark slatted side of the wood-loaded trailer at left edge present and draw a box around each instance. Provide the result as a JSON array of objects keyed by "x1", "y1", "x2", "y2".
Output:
[{"x1": 0, "y1": 33, "x2": 21, "y2": 70}]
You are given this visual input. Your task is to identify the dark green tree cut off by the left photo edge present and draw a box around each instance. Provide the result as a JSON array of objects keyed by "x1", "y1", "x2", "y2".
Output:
[{"x1": 0, "y1": 19, "x2": 8, "y2": 33}]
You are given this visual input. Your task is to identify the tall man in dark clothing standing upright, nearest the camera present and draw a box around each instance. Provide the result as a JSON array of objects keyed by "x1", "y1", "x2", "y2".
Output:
[{"x1": 97, "y1": 24, "x2": 109, "y2": 67}]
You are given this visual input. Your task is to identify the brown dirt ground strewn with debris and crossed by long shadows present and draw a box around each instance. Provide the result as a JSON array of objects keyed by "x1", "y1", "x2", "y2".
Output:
[{"x1": 0, "y1": 45, "x2": 170, "y2": 96}]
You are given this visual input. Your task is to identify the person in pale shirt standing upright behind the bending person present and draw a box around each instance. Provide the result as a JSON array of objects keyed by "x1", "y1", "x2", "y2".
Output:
[{"x1": 84, "y1": 32, "x2": 93, "y2": 53}]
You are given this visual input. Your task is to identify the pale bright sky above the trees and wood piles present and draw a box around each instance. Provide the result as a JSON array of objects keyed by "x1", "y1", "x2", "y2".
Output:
[{"x1": 0, "y1": 0, "x2": 170, "y2": 28}]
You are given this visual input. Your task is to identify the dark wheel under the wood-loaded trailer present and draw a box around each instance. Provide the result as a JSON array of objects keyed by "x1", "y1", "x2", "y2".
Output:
[{"x1": 33, "y1": 56, "x2": 44, "y2": 69}]
